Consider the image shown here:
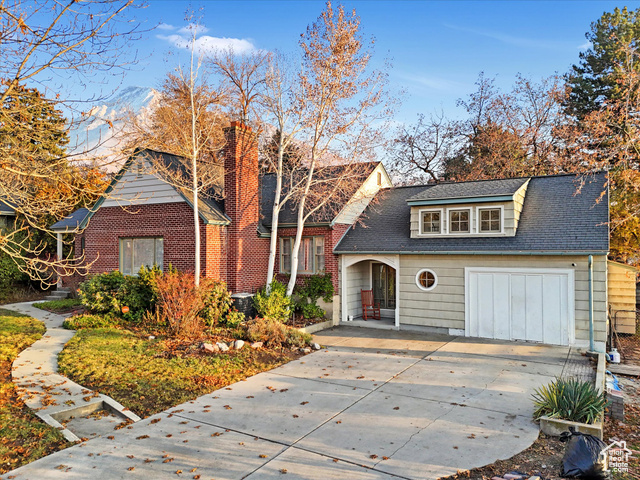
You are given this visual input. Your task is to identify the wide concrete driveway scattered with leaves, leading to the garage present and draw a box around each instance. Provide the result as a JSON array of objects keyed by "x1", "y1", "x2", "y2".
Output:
[{"x1": 3, "y1": 327, "x2": 569, "y2": 480}]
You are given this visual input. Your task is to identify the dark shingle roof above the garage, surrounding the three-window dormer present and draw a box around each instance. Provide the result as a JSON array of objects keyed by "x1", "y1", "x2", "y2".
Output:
[{"x1": 334, "y1": 173, "x2": 609, "y2": 254}]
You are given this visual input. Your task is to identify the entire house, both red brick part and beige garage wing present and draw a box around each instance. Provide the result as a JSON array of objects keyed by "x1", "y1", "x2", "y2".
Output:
[{"x1": 52, "y1": 123, "x2": 609, "y2": 351}]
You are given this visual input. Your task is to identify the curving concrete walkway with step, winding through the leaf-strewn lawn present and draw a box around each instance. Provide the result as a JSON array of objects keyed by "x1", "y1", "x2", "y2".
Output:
[{"x1": 2, "y1": 302, "x2": 140, "y2": 442}]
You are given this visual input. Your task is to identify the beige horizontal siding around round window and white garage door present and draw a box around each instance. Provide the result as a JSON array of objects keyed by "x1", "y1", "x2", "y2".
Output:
[{"x1": 399, "y1": 255, "x2": 607, "y2": 343}]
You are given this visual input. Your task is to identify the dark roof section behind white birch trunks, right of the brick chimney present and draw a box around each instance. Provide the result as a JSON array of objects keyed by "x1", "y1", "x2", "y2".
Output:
[{"x1": 260, "y1": 162, "x2": 380, "y2": 228}]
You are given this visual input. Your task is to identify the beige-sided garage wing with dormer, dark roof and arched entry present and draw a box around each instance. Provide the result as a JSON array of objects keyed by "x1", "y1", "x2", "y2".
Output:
[{"x1": 334, "y1": 173, "x2": 609, "y2": 351}]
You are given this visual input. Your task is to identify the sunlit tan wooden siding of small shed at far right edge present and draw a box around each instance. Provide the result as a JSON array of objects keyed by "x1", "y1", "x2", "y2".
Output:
[{"x1": 607, "y1": 261, "x2": 637, "y2": 333}]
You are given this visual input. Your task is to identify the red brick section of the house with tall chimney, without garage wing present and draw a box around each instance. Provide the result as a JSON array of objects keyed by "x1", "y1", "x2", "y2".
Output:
[{"x1": 52, "y1": 122, "x2": 391, "y2": 318}]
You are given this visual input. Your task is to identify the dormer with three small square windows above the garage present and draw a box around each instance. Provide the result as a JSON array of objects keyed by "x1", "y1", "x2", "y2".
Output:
[{"x1": 407, "y1": 178, "x2": 530, "y2": 238}]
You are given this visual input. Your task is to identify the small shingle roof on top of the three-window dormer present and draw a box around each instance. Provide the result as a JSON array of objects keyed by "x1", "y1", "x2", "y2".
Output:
[{"x1": 407, "y1": 178, "x2": 528, "y2": 202}]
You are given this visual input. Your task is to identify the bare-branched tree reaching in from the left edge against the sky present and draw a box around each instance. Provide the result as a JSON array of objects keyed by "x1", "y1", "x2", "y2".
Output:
[{"x1": 0, "y1": 0, "x2": 138, "y2": 284}]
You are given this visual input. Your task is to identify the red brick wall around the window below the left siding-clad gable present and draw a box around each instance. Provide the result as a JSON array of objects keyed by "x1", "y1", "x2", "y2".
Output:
[{"x1": 68, "y1": 202, "x2": 226, "y2": 284}]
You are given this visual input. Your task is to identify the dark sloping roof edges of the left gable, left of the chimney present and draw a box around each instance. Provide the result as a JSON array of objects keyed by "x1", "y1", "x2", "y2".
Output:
[{"x1": 51, "y1": 149, "x2": 231, "y2": 231}]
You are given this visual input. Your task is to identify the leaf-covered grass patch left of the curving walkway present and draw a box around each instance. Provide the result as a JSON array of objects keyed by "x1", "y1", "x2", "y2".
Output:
[{"x1": 0, "y1": 309, "x2": 69, "y2": 474}]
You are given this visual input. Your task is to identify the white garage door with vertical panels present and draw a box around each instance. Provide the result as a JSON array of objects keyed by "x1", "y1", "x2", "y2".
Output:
[{"x1": 465, "y1": 268, "x2": 575, "y2": 345}]
